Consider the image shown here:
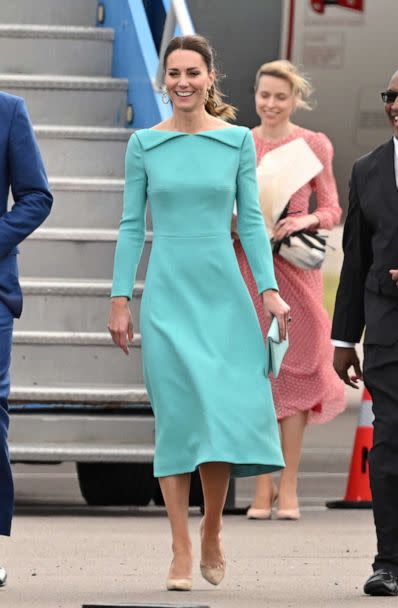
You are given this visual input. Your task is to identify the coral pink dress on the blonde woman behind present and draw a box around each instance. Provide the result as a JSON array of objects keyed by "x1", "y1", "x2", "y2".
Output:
[{"x1": 235, "y1": 127, "x2": 345, "y2": 424}]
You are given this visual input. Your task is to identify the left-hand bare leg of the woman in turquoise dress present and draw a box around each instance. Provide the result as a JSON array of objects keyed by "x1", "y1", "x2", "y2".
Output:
[{"x1": 159, "y1": 473, "x2": 192, "y2": 579}]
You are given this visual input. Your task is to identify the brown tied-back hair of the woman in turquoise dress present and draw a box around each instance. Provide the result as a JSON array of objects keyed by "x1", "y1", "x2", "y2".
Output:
[{"x1": 163, "y1": 34, "x2": 236, "y2": 120}]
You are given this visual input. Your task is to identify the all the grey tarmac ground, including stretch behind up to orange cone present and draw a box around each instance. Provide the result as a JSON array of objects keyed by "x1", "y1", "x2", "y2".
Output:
[{"x1": 0, "y1": 392, "x2": 386, "y2": 608}]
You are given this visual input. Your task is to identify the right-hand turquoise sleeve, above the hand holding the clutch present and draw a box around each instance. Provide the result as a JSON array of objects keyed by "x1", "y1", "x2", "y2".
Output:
[{"x1": 236, "y1": 132, "x2": 278, "y2": 293}]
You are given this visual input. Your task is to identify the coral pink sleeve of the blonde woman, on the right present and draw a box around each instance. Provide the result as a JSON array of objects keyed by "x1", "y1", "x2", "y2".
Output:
[{"x1": 310, "y1": 133, "x2": 342, "y2": 230}]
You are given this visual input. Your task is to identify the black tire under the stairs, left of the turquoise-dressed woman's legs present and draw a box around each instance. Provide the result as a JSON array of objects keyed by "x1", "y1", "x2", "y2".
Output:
[{"x1": 76, "y1": 462, "x2": 155, "y2": 507}]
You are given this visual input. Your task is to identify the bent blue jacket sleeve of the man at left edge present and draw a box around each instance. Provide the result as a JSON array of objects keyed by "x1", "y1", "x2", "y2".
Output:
[{"x1": 0, "y1": 99, "x2": 53, "y2": 258}]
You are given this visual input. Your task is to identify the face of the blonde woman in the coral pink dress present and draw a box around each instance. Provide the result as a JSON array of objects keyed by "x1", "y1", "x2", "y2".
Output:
[{"x1": 255, "y1": 74, "x2": 297, "y2": 127}]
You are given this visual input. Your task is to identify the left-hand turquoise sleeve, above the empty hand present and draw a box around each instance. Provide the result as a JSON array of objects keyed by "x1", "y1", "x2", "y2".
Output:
[{"x1": 112, "y1": 134, "x2": 147, "y2": 299}]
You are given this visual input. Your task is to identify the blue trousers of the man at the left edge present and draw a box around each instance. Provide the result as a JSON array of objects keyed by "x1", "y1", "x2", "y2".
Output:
[{"x1": 0, "y1": 302, "x2": 14, "y2": 536}]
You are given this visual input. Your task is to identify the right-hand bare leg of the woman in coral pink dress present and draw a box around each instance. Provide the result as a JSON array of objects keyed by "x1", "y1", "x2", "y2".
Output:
[{"x1": 278, "y1": 412, "x2": 308, "y2": 510}]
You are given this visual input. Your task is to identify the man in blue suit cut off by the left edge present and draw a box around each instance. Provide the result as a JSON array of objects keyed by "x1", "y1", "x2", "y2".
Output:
[{"x1": 0, "y1": 92, "x2": 52, "y2": 587}]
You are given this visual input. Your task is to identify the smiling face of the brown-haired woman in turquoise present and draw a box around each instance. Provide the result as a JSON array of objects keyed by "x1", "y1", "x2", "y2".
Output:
[{"x1": 164, "y1": 49, "x2": 214, "y2": 112}]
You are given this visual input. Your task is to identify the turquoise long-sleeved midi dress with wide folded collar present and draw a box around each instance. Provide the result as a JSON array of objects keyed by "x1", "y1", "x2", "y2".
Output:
[{"x1": 112, "y1": 127, "x2": 284, "y2": 477}]
